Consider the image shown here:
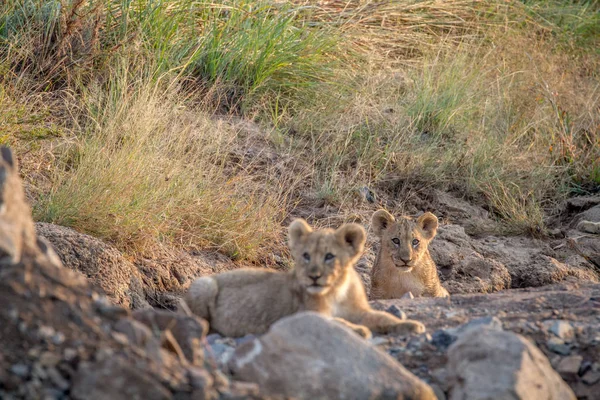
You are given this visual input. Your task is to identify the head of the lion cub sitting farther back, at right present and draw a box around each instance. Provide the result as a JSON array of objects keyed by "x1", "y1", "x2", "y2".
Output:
[{"x1": 371, "y1": 210, "x2": 438, "y2": 272}]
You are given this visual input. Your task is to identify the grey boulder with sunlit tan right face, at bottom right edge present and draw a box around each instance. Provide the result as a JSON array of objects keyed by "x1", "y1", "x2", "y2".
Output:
[{"x1": 448, "y1": 327, "x2": 575, "y2": 400}]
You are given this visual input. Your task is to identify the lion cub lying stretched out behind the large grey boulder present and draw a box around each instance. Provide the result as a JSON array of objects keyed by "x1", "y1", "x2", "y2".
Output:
[{"x1": 185, "y1": 219, "x2": 425, "y2": 337}]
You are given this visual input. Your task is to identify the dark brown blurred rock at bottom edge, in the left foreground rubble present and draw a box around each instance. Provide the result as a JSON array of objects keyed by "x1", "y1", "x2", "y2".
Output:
[{"x1": 71, "y1": 358, "x2": 172, "y2": 400}]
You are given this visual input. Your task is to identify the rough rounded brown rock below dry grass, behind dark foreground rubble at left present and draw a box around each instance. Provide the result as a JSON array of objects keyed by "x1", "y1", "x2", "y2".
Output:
[{"x1": 36, "y1": 222, "x2": 147, "y2": 308}]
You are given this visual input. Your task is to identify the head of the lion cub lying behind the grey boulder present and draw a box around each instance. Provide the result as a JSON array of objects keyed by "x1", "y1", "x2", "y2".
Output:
[{"x1": 288, "y1": 219, "x2": 366, "y2": 295}]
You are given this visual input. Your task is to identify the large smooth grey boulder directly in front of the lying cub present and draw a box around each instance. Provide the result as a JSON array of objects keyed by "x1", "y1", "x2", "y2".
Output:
[{"x1": 230, "y1": 312, "x2": 435, "y2": 399}]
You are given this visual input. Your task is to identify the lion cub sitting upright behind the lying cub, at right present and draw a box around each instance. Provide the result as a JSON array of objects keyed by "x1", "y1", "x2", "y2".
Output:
[{"x1": 371, "y1": 210, "x2": 450, "y2": 299}]
